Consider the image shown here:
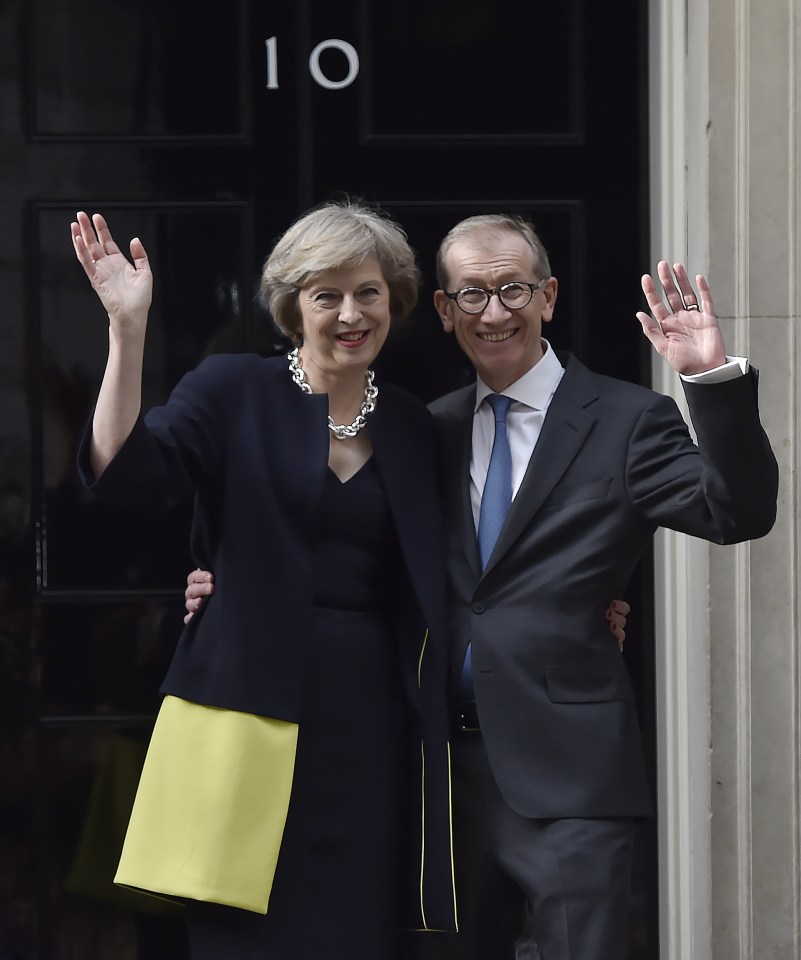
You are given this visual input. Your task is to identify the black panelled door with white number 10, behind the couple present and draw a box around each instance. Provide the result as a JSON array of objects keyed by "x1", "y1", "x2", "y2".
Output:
[{"x1": 0, "y1": 0, "x2": 657, "y2": 960}]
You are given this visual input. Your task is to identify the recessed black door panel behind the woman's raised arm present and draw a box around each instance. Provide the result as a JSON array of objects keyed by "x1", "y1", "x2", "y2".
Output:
[{"x1": 29, "y1": 198, "x2": 253, "y2": 601}]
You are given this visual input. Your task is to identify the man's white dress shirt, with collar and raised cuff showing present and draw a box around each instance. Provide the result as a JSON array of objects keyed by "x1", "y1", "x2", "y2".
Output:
[{"x1": 470, "y1": 340, "x2": 748, "y2": 530}]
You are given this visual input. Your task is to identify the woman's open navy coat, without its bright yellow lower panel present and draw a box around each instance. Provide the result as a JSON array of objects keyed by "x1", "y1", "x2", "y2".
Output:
[{"x1": 79, "y1": 354, "x2": 454, "y2": 929}]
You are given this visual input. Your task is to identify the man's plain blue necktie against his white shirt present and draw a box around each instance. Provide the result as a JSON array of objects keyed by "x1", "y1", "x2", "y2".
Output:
[{"x1": 461, "y1": 393, "x2": 512, "y2": 700}]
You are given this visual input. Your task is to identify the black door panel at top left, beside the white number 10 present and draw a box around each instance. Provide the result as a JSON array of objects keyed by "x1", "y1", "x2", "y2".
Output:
[{"x1": 25, "y1": 0, "x2": 251, "y2": 145}]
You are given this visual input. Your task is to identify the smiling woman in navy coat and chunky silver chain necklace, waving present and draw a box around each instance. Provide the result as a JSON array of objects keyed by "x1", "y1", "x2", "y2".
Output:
[{"x1": 71, "y1": 204, "x2": 456, "y2": 960}]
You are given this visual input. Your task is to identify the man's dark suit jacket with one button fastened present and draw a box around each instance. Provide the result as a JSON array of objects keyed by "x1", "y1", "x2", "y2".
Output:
[{"x1": 431, "y1": 355, "x2": 778, "y2": 818}]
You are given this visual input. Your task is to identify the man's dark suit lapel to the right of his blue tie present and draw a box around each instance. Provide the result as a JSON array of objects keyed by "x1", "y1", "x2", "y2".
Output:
[{"x1": 484, "y1": 355, "x2": 598, "y2": 575}]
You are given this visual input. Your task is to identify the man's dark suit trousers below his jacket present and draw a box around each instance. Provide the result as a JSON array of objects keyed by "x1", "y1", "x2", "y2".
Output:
[{"x1": 404, "y1": 732, "x2": 636, "y2": 960}]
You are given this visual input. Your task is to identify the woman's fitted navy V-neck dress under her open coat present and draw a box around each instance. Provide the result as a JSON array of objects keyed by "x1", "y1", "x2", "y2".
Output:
[{"x1": 187, "y1": 459, "x2": 404, "y2": 960}]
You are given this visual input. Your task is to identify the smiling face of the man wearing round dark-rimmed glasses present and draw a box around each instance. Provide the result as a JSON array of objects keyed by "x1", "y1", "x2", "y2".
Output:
[{"x1": 434, "y1": 231, "x2": 557, "y2": 392}]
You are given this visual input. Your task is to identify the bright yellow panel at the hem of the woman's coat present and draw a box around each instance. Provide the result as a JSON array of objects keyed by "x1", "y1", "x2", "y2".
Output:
[{"x1": 114, "y1": 697, "x2": 298, "y2": 914}]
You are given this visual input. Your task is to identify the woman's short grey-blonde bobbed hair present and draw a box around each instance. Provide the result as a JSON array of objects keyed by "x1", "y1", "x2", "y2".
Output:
[{"x1": 261, "y1": 200, "x2": 420, "y2": 344}]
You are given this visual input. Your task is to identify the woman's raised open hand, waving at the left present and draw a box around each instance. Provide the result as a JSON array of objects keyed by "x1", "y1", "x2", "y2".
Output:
[{"x1": 70, "y1": 211, "x2": 153, "y2": 335}]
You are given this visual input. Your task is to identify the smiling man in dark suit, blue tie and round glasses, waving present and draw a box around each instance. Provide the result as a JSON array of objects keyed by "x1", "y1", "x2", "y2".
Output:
[{"x1": 188, "y1": 216, "x2": 778, "y2": 960}]
